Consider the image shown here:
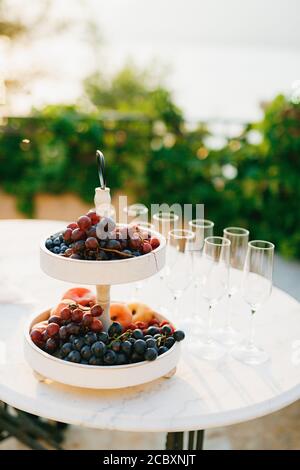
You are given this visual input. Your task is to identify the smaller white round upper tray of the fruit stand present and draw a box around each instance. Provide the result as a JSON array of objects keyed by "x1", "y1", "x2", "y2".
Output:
[{"x1": 40, "y1": 230, "x2": 166, "y2": 285}]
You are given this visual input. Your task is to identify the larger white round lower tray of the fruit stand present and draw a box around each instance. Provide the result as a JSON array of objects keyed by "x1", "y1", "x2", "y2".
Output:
[{"x1": 24, "y1": 310, "x2": 180, "y2": 389}]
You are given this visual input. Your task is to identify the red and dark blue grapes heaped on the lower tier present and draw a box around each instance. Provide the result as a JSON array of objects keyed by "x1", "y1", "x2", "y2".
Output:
[{"x1": 30, "y1": 303, "x2": 185, "y2": 366}]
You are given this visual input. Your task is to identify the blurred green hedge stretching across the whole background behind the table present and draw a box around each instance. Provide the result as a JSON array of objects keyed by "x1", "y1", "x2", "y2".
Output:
[{"x1": 0, "y1": 87, "x2": 300, "y2": 258}]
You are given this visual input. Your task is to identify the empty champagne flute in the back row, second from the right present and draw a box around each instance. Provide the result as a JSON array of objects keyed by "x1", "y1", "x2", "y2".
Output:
[{"x1": 188, "y1": 219, "x2": 215, "y2": 324}]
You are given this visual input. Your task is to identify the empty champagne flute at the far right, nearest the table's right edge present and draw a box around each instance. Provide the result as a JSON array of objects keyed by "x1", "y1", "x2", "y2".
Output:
[{"x1": 232, "y1": 240, "x2": 274, "y2": 365}]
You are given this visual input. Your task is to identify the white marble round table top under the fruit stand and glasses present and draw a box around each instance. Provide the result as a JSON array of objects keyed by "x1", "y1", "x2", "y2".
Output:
[{"x1": 0, "y1": 221, "x2": 300, "y2": 432}]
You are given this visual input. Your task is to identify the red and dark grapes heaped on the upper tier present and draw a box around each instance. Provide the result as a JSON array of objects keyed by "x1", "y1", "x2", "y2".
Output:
[{"x1": 45, "y1": 209, "x2": 160, "y2": 261}]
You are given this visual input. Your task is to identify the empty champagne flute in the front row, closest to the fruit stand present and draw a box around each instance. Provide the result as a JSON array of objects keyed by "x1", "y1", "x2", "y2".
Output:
[{"x1": 166, "y1": 229, "x2": 195, "y2": 328}]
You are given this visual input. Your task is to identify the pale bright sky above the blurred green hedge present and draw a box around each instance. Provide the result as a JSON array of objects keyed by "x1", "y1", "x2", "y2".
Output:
[{"x1": 0, "y1": 0, "x2": 300, "y2": 120}]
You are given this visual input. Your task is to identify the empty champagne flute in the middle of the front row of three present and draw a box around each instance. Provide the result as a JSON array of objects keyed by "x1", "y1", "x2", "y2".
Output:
[{"x1": 191, "y1": 237, "x2": 230, "y2": 360}]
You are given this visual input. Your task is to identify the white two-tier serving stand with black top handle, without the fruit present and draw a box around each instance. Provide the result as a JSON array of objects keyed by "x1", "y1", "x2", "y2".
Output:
[{"x1": 24, "y1": 154, "x2": 180, "y2": 389}]
